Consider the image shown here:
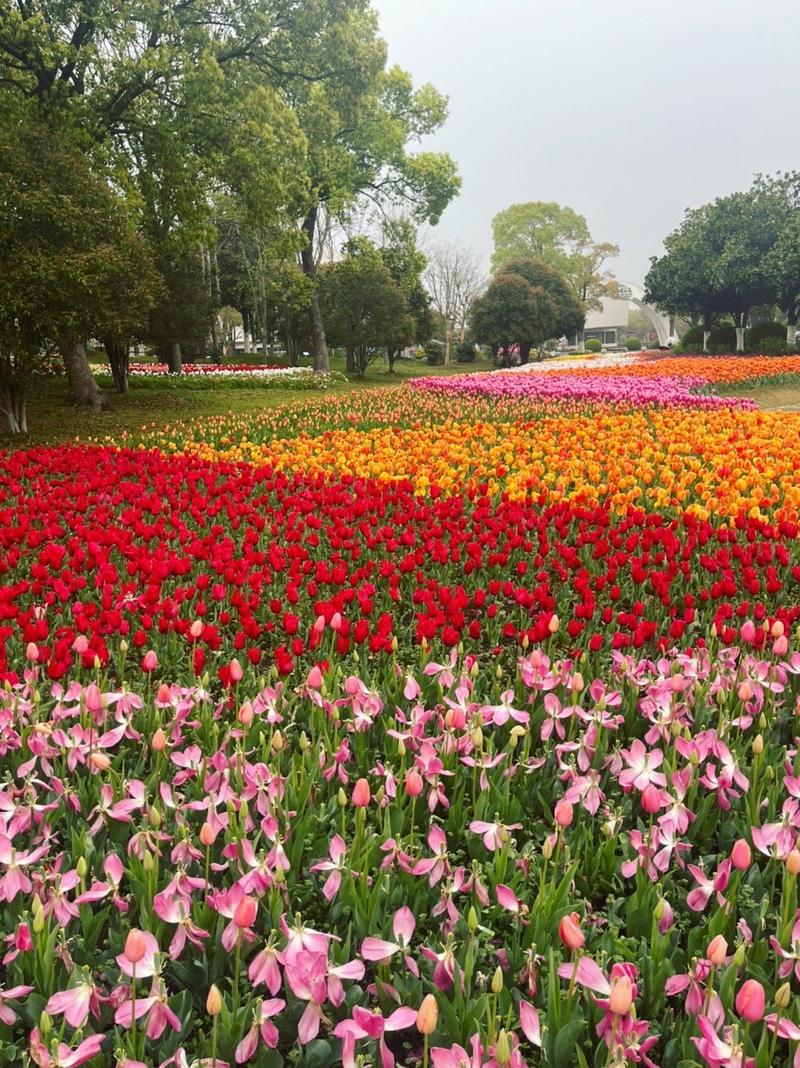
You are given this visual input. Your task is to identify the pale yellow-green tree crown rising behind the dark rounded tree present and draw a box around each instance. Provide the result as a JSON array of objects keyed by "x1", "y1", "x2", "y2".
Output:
[{"x1": 491, "y1": 201, "x2": 619, "y2": 309}]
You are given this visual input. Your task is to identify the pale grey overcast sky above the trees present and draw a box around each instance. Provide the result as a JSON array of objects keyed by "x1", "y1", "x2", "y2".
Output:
[{"x1": 374, "y1": 0, "x2": 800, "y2": 282}]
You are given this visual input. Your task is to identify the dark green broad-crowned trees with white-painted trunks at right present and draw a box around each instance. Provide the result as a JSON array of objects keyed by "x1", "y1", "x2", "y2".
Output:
[{"x1": 645, "y1": 171, "x2": 800, "y2": 351}]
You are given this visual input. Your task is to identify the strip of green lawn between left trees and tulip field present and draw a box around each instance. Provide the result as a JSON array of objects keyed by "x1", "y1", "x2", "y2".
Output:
[{"x1": 0, "y1": 359, "x2": 487, "y2": 449}]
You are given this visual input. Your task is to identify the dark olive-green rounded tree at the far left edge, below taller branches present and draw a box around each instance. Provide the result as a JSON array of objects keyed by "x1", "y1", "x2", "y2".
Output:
[{"x1": 0, "y1": 99, "x2": 160, "y2": 430}]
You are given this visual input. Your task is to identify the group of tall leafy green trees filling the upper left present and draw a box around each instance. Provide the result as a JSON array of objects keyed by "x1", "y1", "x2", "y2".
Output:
[{"x1": 0, "y1": 0, "x2": 459, "y2": 429}]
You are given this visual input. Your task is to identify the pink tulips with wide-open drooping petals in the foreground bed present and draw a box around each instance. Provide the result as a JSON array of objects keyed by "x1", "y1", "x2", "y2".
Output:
[{"x1": 0, "y1": 621, "x2": 800, "y2": 1068}]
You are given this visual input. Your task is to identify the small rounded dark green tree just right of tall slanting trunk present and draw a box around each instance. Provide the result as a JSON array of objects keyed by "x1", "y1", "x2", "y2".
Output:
[{"x1": 319, "y1": 238, "x2": 417, "y2": 378}]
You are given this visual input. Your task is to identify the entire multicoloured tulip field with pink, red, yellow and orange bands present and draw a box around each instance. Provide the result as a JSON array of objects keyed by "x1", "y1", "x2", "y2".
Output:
[{"x1": 7, "y1": 355, "x2": 800, "y2": 1068}]
